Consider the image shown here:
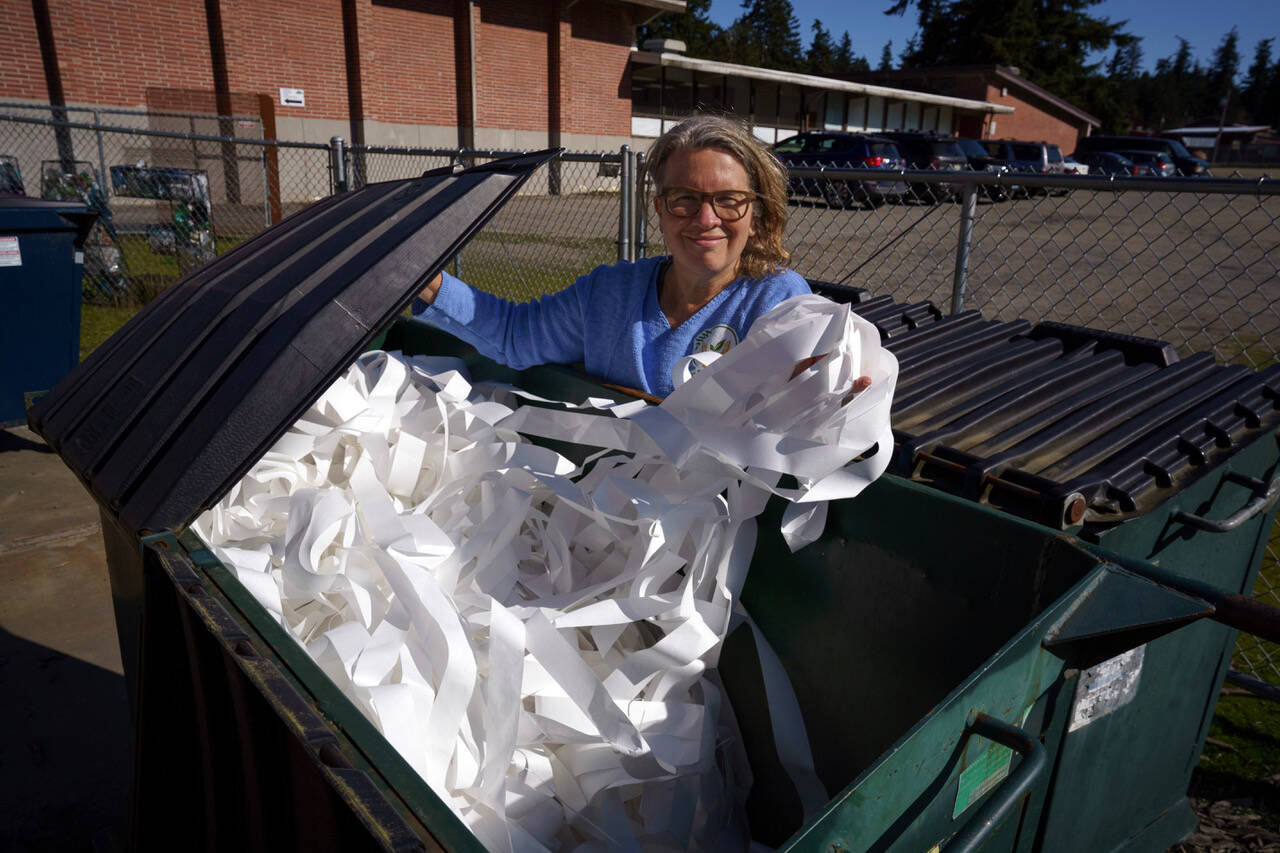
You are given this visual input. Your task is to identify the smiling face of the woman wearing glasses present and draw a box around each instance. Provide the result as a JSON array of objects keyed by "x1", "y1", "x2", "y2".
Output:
[{"x1": 654, "y1": 149, "x2": 755, "y2": 289}]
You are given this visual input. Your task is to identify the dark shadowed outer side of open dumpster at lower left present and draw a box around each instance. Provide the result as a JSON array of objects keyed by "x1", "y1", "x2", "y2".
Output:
[{"x1": 133, "y1": 534, "x2": 475, "y2": 850}]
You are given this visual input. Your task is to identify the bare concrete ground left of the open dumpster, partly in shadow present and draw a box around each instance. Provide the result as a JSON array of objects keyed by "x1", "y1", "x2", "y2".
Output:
[{"x1": 0, "y1": 428, "x2": 132, "y2": 853}]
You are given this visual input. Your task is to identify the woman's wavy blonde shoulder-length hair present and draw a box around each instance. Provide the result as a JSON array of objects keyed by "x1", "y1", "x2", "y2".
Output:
[{"x1": 645, "y1": 115, "x2": 791, "y2": 279}]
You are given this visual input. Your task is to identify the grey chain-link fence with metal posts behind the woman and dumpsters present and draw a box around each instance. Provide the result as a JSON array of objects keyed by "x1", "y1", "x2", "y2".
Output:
[{"x1": 0, "y1": 105, "x2": 1280, "y2": 684}]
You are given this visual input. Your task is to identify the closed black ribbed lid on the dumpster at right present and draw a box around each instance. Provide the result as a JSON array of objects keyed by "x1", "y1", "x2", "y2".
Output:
[{"x1": 814, "y1": 283, "x2": 1280, "y2": 528}]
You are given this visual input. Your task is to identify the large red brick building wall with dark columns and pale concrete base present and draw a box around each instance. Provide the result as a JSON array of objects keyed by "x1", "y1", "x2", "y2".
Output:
[{"x1": 0, "y1": 0, "x2": 685, "y2": 150}]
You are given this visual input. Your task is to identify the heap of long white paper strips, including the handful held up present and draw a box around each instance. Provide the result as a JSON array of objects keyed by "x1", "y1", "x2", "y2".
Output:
[{"x1": 196, "y1": 297, "x2": 897, "y2": 850}]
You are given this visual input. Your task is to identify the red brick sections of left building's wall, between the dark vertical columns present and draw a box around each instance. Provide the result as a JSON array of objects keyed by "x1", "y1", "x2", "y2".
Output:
[{"x1": 0, "y1": 0, "x2": 631, "y2": 136}]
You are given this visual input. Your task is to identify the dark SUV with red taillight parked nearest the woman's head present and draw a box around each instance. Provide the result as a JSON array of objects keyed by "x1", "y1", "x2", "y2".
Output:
[{"x1": 773, "y1": 131, "x2": 908, "y2": 209}]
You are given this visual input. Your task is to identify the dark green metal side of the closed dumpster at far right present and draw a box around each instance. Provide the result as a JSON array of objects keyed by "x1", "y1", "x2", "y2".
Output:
[{"x1": 1042, "y1": 437, "x2": 1280, "y2": 853}]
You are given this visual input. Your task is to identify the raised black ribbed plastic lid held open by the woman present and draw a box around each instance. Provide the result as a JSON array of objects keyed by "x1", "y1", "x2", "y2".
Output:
[{"x1": 28, "y1": 149, "x2": 559, "y2": 532}]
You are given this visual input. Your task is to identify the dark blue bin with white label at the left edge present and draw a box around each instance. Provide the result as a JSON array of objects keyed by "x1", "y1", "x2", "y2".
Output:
[{"x1": 0, "y1": 196, "x2": 96, "y2": 425}]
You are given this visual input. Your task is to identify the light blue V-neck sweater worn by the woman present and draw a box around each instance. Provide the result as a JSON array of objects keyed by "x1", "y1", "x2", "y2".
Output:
[{"x1": 413, "y1": 257, "x2": 810, "y2": 396}]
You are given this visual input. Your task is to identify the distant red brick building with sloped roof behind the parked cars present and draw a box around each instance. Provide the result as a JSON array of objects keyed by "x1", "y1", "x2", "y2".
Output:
[{"x1": 849, "y1": 65, "x2": 1101, "y2": 154}]
